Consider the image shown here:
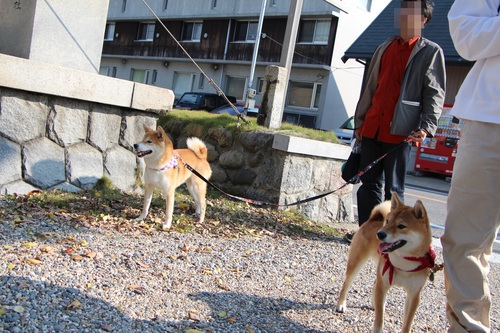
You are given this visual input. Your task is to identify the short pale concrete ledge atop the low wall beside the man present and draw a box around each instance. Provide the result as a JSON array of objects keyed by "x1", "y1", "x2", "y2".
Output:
[{"x1": 273, "y1": 134, "x2": 351, "y2": 160}]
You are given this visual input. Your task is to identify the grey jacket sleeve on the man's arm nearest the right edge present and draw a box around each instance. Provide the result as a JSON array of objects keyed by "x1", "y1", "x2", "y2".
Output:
[{"x1": 420, "y1": 48, "x2": 446, "y2": 136}]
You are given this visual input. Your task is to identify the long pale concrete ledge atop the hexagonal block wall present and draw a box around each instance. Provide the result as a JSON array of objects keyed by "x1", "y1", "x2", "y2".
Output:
[{"x1": 0, "y1": 54, "x2": 174, "y2": 113}]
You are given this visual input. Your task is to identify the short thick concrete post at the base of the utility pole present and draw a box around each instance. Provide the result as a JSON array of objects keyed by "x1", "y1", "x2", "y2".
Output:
[{"x1": 257, "y1": 66, "x2": 288, "y2": 129}]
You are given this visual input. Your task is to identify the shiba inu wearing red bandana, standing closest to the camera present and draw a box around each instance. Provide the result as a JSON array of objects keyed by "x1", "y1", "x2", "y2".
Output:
[{"x1": 336, "y1": 193, "x2": 436, "y2": 333}]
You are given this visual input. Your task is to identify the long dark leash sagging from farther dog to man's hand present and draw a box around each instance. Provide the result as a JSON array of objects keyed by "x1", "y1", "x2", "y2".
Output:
[{"x1": 178, "y1": 136, "x2": 411, "y2": 207}]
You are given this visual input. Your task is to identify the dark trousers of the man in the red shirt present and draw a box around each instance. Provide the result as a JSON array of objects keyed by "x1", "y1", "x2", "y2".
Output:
[{"x1": 357, "y1": 137, "x2": 411, "y2": 226}]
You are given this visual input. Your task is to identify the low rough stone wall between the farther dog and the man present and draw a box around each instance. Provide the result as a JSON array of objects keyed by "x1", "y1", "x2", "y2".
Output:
[{"x1": 164, "y1": 122, "x2": 354, "y2": 224}]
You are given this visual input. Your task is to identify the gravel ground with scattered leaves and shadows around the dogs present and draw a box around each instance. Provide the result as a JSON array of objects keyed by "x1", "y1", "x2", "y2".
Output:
[{"x1": 0, "y1": 193, "x2": 500, "y2": 333}]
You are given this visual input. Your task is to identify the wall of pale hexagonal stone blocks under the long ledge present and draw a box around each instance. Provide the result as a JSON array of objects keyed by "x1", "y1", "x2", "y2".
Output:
[{"x1": 0, "y1": 87, "x2": 158, "y2": 194}]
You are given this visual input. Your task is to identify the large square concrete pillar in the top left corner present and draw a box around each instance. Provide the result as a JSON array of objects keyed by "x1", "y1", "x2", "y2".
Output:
[{"x1": 0, "y1": 0, "x2": 109, "y2": 73}]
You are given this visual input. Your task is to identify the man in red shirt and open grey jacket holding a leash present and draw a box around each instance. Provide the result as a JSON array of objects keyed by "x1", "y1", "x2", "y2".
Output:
[{"x1": 345, "y1": 0, "x2": 446, "y2": 241}]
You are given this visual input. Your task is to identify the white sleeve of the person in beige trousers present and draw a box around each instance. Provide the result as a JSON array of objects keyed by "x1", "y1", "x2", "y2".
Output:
[{"x1": 448, "y1": 0, "x2": 500, "y2": 61}]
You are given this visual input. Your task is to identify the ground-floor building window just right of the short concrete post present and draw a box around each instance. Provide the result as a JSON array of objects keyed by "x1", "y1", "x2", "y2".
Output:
[{"x1": 286, "y1": 81, "x2": 321, "y2": 109}]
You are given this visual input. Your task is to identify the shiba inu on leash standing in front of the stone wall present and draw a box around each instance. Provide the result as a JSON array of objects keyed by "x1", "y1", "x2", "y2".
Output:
[{"x1": 134, "y1": 125, "x2": 212, "y2": 230}]
